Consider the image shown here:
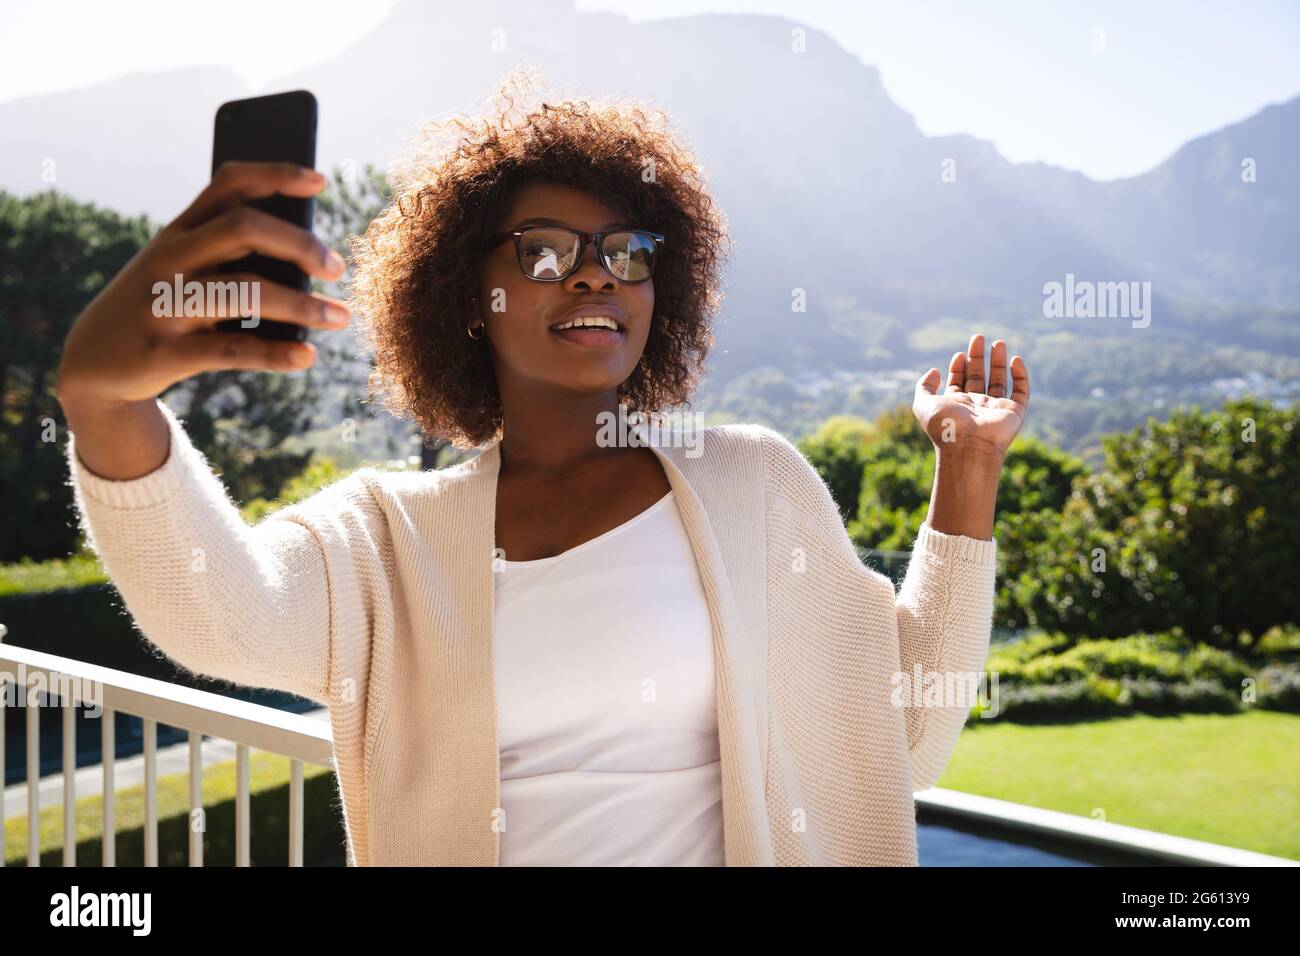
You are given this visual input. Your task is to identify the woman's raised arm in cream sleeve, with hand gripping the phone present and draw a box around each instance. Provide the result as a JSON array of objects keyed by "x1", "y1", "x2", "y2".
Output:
[{"x1": 55, "y1": 161, "x2": 361, "y2": 698}]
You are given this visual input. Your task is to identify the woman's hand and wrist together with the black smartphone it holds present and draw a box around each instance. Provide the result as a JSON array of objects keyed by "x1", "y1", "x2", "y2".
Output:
[{"x1": 55, "y1": 83, "x2": 351, "y2": 447}]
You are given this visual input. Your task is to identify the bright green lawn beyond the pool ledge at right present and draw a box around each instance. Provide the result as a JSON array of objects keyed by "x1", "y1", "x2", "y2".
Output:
[{"x1": 936, "y1": 710, "x2": 1300, "y2": 860}]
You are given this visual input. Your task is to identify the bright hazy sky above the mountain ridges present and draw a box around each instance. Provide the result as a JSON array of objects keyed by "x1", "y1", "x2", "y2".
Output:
[{"x1": 0, "y1": 0, "x2": 1300, "y2": 179}]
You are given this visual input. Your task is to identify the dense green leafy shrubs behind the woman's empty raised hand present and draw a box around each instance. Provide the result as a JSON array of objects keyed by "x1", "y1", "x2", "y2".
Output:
[{"x1": 809, "y1": 398, "x2": 1300, "y2": 647}]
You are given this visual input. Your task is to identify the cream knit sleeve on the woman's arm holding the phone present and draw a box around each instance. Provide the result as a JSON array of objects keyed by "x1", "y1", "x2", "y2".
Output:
[{"x1": 68, "y1": 401, "x2": 378, "y2": 704}]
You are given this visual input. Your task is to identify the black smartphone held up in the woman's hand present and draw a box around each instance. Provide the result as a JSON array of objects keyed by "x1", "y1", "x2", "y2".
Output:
[{"x1": 212, "y1": 90, "x2": 316, "y2": 342}]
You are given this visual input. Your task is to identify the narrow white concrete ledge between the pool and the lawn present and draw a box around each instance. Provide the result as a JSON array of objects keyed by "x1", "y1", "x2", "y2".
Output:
[{"x1": 914, "y1": 787, "x2": 1300, "y2": 866}]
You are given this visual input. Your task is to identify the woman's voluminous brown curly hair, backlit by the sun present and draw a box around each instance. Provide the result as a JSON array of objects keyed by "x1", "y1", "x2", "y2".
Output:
[{"x1": 350, "y1": 69, "x2": 731, "y2": 450}]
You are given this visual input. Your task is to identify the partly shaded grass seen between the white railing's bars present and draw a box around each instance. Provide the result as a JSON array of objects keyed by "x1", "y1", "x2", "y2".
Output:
[{"x1": 4, "y1": 750, "x2": 345, "y2": 866}]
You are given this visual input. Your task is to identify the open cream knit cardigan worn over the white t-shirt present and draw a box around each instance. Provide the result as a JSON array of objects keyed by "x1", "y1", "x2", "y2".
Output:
[{"x1": 66, "y1": 401, "x2": 996, "y2": 866}]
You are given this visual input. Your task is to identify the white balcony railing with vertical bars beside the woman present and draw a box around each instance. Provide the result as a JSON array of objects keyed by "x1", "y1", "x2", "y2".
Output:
[{"x1": 0, "y1": 624, "x2": 334, "y2": 866}]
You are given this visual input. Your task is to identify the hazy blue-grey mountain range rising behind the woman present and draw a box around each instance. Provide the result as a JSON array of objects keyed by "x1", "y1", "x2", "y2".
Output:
[{"x1": 0, "y1": 0, "x2": 1300, "y2": 447}]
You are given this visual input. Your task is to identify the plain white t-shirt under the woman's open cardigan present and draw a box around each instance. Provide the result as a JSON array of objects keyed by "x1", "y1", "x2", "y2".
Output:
[{"x1": 493, "y1": 492, "x2": 723, "y2": 866}]
